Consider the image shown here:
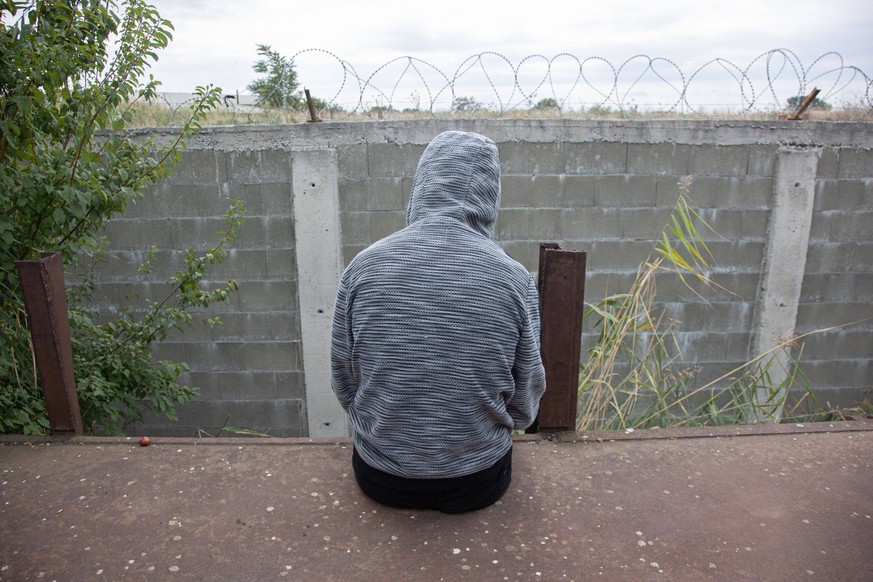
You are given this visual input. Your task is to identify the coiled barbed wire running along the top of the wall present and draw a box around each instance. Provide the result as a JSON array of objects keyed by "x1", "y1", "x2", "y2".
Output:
[{"x1": 153, "y1": 48, "x2": 873, "y2": 119}]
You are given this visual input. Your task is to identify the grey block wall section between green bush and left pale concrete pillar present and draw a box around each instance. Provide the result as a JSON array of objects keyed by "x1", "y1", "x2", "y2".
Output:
[{"x1": 107, "y1": 149, "x2": 308, "y2": 436}]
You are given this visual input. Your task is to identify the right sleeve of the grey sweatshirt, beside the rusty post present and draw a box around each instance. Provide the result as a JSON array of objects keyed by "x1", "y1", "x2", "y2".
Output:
[{"x1": 507, "y1": 278, "x2": 546, "y2": 429}]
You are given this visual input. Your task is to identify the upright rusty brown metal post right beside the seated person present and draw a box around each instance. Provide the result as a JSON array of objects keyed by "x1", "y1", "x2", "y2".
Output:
[{"x1": 529, "y1": 243, "x2": 588, "y2": 432}]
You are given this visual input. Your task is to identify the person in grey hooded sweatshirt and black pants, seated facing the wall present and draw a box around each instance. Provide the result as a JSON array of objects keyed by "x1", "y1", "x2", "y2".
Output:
[{"x1": 331, "y1": 131, "x2": 545, "y2": 513}]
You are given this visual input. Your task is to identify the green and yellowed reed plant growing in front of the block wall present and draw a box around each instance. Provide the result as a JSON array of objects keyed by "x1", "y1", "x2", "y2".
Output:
[{"x1": 576, "y1": 177, "x2": 829, "y2": 430}]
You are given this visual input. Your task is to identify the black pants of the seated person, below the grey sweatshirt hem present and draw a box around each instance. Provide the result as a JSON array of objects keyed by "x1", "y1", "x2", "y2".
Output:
[{"x1": 352, "y1": 448, "x2": 512, "y2": 513}]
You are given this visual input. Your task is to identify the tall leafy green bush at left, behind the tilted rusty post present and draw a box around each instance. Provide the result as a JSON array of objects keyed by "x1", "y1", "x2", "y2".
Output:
[{"x1": 0, "y1": 0, "x2": 243, "y2": 434}]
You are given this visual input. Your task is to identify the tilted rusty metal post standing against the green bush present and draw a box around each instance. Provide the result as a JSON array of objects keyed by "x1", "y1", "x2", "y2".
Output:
[{"x1": 15, "y1": 253, "x2": 83, "y2": 435}]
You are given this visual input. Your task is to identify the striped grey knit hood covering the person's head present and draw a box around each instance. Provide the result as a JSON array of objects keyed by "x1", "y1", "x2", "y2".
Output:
[{"x1": 406, "y1": 131, "x2": 500, "y2": 238}]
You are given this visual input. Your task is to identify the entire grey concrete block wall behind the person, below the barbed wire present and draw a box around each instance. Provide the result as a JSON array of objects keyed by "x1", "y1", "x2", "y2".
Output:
[{"x1": 92, "y1": 120, "x2": 873, "y2": 436}]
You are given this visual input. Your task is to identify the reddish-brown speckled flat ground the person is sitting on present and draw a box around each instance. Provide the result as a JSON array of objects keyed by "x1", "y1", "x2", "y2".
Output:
[{"x1": 0, "y1": 421, "x2": 873, "y2": 582}]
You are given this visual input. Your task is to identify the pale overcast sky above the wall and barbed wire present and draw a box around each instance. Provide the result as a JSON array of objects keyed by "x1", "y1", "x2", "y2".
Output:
[{"x1": 146, "y1": 0, "x2": 873, "y2": 112}]
